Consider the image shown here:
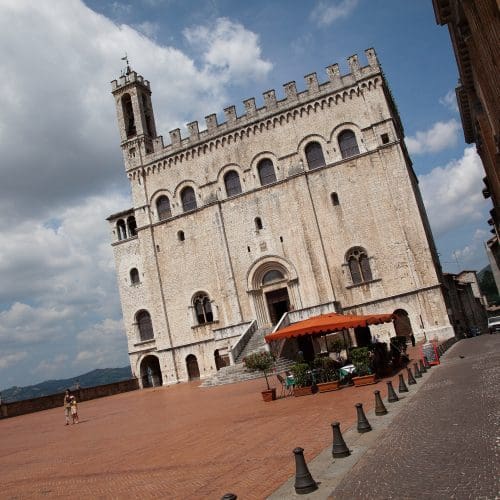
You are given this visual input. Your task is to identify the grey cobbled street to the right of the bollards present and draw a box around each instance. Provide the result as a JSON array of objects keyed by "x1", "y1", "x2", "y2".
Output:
[{"x1": 331, "y1": 335, "x2": 500, "y2": 500}]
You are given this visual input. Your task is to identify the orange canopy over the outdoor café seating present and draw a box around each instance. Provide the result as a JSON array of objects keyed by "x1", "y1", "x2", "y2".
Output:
[{"x1": 265, "y1": 313, "x2": 393, "y2": 342}]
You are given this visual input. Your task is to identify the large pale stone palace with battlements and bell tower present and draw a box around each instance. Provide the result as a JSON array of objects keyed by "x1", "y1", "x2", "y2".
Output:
[{"x1": 108, "y1": 49, "x2": 454, "y2": 385}]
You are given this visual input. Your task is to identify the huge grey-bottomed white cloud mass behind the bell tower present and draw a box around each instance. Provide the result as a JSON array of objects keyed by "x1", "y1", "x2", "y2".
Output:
[{"x1": 0, "y1": 0, "x2": 272, "y2": 228}]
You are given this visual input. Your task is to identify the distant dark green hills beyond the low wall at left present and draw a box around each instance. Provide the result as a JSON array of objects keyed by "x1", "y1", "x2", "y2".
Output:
[{"x1": 1, "y1": 366, "x2": 132, "y2": 403}]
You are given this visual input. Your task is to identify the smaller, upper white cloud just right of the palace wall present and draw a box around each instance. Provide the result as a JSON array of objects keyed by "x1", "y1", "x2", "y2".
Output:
[{"x1": 405, "y1": 118, "x2": 460, "y2": 154}]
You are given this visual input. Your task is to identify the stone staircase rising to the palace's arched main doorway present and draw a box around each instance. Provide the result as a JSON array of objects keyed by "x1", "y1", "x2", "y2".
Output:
[{"x1": 201, "y1": 328, "x2": 293, "y2": 387}]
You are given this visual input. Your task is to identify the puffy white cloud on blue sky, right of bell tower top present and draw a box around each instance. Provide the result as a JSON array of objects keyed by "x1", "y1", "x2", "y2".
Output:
[{"x1": 184, "y1": 18, "x2": 273, "y2": 82}]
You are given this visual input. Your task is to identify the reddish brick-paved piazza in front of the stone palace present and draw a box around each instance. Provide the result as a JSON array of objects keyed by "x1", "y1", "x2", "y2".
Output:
[{"x1": 0, "y1": 350, "x2": 422, "y2": 499}]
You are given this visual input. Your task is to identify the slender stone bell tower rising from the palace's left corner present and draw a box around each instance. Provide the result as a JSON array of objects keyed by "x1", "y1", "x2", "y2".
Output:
[{"x1": 111, "y1": 61, "x2": 157, "y2": 170}]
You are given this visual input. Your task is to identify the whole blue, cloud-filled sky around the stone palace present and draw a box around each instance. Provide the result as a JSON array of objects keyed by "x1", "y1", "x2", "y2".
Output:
[{"x1": 0, "y1": 0, "x2": 490, "y2": 389}]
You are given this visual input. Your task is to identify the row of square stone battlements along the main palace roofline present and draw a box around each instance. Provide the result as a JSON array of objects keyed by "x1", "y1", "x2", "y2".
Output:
[{"x1": 155, "y1": 48, "x2": 381, "y2": 154}]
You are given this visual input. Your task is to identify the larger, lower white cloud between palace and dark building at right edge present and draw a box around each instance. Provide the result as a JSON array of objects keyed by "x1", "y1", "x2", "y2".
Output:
[{"x1": 419, "y1": 147, "x2": 488, "y2": 236}]
